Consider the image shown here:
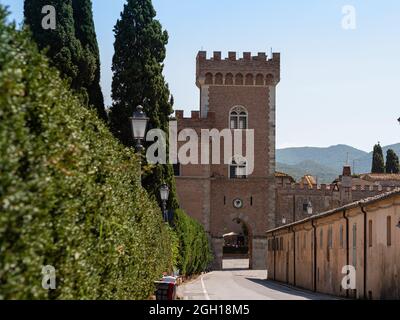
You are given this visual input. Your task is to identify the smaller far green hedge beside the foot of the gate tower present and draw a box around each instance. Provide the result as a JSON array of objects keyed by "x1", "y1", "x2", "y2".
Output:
[{"x1": 174, "y1": 209, "x2": 212, "y2": 275}]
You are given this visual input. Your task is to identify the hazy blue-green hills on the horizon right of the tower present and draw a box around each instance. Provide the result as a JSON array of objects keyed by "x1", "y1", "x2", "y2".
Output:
[{"x1": 276, "y1": 143, "x2": 400, "y2": 183}]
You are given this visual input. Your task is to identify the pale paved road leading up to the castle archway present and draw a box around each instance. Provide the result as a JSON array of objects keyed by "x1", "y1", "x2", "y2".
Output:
[{"x1": 178, "y1": 258, "x2": 333, "y2": 300}]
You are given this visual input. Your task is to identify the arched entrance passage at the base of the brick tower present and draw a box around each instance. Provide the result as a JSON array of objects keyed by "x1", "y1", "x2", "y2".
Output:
[{"x1": 222, "y1": 218, "x2": 252, "y2": 270}]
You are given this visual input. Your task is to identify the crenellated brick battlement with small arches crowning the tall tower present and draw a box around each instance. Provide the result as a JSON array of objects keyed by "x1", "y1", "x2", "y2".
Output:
[{"x1": 196, "y1": 51, "x2": 280, "y2": 88}]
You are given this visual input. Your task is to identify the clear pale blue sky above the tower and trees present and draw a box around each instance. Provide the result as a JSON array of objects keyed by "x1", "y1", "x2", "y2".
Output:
[{"x1": 0, "y1": 0, "x2": 400, "y2": 151}]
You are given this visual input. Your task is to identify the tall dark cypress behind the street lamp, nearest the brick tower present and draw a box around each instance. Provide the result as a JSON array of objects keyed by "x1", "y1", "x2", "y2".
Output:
[{"x1": 110, "y1": 0, "x2": 177, "y2": 207}]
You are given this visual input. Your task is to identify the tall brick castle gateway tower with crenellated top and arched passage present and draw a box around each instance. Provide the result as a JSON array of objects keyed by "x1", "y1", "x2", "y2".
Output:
[{"x1": 176, "y1": 51, "x2": 280, "y2": 270}]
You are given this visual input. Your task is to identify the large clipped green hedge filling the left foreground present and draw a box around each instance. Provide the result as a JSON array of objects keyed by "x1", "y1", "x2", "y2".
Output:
[{"x1": 0, "y1": 8, "x2": 176, "y2": 299}]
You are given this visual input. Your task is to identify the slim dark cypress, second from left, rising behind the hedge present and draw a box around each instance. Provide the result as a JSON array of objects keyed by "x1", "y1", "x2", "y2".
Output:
[{"x1": 72, "y1": 0, "x2": 107, "y2": 120}]
